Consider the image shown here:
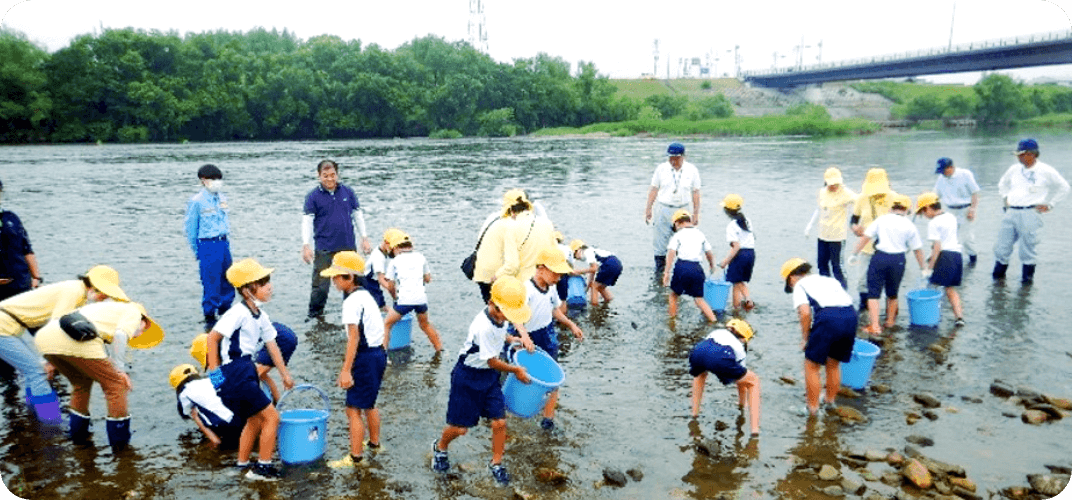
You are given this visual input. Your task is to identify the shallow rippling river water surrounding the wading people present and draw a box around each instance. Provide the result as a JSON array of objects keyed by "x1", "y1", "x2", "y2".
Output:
[{"x1": 0, "y1": 133, "x2": 1072, "y2": 499}]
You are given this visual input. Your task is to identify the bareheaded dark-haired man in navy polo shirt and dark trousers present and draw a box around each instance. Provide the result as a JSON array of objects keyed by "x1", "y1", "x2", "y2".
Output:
[{"x1": 301, "y1": 160, "x2": 372, "y2": 318}]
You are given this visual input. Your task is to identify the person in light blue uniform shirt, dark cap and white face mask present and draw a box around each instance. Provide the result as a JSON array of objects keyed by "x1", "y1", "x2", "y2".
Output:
[{"x1": 185, "y1": 164, "x2": 235, "y2": 332}]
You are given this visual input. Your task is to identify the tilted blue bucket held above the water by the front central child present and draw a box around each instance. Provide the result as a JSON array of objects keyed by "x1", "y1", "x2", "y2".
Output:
[{"x1": 503, "y1": 349, "x2": 566, "y2": 418}]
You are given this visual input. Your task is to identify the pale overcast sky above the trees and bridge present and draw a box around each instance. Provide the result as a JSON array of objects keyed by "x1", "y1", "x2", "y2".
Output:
[{"x1": 0, "y1": 0, "x2": 1072, "y2": 84}]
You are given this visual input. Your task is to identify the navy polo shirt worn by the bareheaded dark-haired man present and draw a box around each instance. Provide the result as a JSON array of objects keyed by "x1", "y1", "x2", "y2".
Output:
[{"x1": 302, "y1": 183, "x2": 361, "y2": 252}]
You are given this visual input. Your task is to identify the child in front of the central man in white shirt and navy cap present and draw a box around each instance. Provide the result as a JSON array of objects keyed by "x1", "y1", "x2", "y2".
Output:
[{"x1": 662, "y1": 209, "x2": 725, "y2": 323}]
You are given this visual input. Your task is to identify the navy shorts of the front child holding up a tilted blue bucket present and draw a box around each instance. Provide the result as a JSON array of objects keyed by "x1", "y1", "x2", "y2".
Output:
[{"x1": 447, "y1": 361, "x2": 506, "y2": 428}]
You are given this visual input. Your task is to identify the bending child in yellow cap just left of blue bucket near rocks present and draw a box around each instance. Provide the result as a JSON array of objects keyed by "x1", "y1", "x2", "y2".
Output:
[{"x1": 781, "y1": 258, "x2": 857, "y2": 415}]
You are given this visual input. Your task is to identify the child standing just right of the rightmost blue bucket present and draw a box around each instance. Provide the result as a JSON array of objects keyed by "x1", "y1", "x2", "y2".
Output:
[{"x1": 915, "y1": 192, "x2": 964, "y2": 326}]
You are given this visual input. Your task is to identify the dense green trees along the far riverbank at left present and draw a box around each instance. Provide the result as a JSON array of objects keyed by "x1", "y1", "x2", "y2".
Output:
[{"x1": 0, "y1": 29, "x2": 651, "y2": 143}]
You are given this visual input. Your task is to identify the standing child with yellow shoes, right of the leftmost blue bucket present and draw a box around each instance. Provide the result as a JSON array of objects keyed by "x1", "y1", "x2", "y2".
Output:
[{"x1": 321, "y1": 251, "x2": 387, "y2": 469}]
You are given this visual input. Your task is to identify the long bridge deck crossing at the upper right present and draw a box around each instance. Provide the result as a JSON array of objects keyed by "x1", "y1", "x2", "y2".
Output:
[{"x1": 741, "y1": 30, "x2": 1072, "y2": 88}]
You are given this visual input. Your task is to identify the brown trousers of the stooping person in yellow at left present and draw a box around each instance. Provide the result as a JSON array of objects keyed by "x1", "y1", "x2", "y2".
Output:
[{"x1": 45, "y1": 354, "x2": 130, "y2": 418}]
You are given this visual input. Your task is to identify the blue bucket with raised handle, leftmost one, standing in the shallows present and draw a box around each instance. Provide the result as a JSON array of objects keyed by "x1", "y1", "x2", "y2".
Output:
[{"x1": 277, "y1": 384, "x2": 330, "y2": 464}]
